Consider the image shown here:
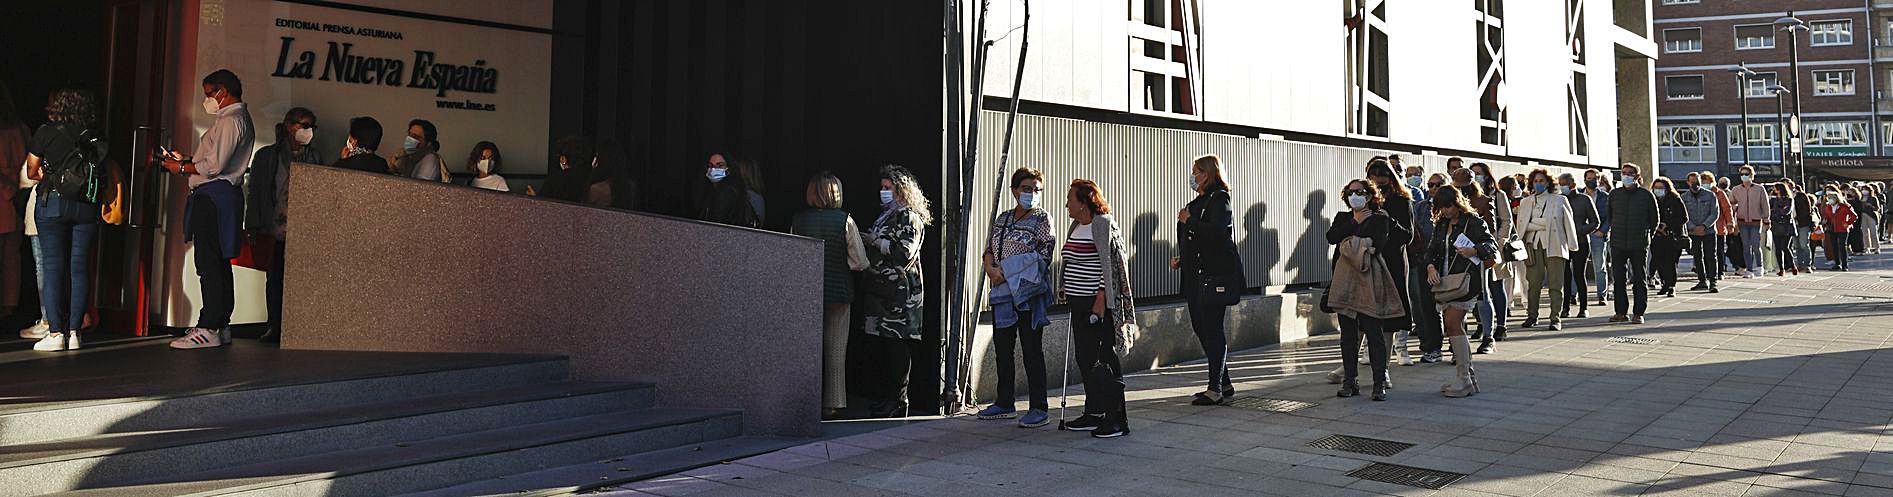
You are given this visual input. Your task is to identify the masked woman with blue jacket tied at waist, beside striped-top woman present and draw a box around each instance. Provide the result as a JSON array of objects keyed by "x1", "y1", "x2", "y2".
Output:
[{"x1": 979, "y1": 168, "x2": 1060, "y2": 427}]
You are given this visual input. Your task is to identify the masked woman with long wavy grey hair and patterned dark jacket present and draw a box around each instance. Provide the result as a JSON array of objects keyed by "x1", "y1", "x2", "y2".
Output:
[{"x1": 866, "y1": 166, "x2": 939, "y2": 418}]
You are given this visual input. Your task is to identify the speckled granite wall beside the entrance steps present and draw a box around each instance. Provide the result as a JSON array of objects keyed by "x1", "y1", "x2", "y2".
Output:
[{"x1": 282, "y1": 164, "x2": 822, "y2": 437}]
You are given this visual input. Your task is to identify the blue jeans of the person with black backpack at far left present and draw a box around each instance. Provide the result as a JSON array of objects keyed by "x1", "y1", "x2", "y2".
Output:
[{"x1": 34, "y1": 204, "x2": 98, "y2": 331}]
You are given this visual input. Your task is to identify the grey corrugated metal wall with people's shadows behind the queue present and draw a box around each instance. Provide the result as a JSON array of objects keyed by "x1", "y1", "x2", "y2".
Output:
[{"x1": 965, "y1": 111, "x2": 1567, "y2": 311}]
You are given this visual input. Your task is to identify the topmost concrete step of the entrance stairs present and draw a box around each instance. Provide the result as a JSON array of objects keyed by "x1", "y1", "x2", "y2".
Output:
[{"x1": 0, "y1": 359, "x2": 570, "y2": 446}]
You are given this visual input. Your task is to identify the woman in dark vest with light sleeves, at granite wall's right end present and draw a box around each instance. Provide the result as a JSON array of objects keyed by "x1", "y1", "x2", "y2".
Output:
[{"x1": 789, "y1": 172, "x2": 867, "y2": 420}]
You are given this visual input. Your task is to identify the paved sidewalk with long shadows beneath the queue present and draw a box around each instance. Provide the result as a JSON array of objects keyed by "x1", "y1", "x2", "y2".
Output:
[{"x1": 606, "y1": 257, "x2": 1893, "y2": 497}]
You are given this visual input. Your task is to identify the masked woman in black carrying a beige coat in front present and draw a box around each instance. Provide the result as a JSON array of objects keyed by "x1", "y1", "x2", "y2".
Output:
[{"x1": 1321, "y1": 180, "x2": 1412, "y2": 401}]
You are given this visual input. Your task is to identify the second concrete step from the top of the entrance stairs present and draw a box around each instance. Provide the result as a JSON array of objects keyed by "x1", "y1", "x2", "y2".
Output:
[{"x1": 0, "y1": 384, "x2": 655, "y2": 495}]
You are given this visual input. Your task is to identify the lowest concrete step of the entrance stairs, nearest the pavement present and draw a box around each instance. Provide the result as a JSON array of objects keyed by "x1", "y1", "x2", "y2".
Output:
[{"x1": 401, "y1": 437, "x2": 806, "y2": 497}]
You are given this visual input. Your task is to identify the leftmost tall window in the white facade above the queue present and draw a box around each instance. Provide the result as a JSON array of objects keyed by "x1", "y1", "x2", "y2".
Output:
[{"x1": 1130, "y1": 0, "x2": 1202, "y2": 115}]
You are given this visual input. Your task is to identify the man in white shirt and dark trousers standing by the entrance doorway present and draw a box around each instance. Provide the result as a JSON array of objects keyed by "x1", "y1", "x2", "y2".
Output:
[{"x1": 165, "y1": 70, "x2": 256, "y2": 350}]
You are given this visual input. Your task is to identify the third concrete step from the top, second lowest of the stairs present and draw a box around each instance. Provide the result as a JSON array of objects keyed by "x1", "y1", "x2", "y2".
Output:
[{"x1": 59, "y1": 408, "x2": 742, "y2": 497}]
